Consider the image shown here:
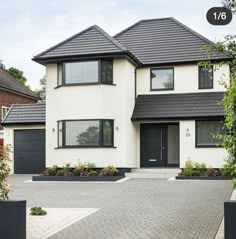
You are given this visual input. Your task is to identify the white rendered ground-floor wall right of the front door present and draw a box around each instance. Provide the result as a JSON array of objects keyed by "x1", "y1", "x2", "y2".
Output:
[{"x1": 180, "y1": 120, "x2": 227, "y2": 168}]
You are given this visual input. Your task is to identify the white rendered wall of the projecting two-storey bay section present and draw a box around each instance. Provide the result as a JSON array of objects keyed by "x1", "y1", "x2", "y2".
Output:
[{"x1": 46, "y1": 59, "x2": 138, "y2": 167}]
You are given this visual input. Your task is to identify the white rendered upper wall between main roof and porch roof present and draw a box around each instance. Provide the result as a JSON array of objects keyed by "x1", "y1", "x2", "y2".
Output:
[{"x1": 137, "y1": 64, "x2": 229, "y2": 94}]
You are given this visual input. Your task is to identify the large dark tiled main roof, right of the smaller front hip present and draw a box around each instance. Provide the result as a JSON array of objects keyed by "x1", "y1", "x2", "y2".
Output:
[{"x1": 114, "y1": 18, "x2": 228, "y2": 65}]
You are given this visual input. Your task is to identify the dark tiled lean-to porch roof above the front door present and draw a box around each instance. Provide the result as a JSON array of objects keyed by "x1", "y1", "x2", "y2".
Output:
[{"x1": 132, "y1": 92, "x2": 225, "y2": 120}]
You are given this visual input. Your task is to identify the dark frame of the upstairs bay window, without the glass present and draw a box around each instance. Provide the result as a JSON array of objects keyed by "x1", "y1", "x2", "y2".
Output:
[{"x1": 55, "y1": 59, "x2": 114, "y2": 88}]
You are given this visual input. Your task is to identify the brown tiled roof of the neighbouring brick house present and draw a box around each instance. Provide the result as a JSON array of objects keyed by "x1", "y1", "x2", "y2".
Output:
[{"x1": 0, "y1": 68, "x2": 39, "y2": 99}]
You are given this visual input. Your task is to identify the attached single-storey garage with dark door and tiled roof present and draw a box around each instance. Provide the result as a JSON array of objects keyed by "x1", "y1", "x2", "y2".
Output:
[{"x1": 2, "y1": 103, "x2": 45, "y2": 174}]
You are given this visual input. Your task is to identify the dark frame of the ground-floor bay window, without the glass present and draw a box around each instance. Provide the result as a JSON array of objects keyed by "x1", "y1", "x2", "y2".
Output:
[{"x1": 57, "y1": 119, "x2": 115, "y2": 148}]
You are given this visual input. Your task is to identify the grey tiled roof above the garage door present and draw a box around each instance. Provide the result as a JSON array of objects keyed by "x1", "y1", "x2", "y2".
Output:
[{"x1": 2, "y1": 103, "x2": 46, "y2": 125}]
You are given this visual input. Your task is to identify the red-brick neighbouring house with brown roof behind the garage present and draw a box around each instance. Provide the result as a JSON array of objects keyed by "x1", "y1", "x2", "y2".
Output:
[{"x1": 0, "y1": 67, "x2": 39, "y2": 145}]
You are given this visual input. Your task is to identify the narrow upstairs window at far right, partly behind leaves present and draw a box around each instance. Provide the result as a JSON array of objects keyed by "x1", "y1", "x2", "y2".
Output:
[{"x1": 198, "y1": 66, "x2": 213, "y2": 89}]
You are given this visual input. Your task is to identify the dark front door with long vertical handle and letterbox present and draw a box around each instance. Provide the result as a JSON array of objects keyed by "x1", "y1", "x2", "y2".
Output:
[{"x1": 140, "y1": 124, "x2": 167, "y2": 167}]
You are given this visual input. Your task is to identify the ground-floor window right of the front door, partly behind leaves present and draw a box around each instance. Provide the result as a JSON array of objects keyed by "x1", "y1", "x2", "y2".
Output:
[{"x1": 196, "y1": 120, "x2": 225, "y2": 147}]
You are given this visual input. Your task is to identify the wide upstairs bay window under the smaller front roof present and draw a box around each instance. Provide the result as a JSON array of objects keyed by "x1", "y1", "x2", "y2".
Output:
[{"x1": 58, "y1": 60, "x2": 113, "y2": 85}]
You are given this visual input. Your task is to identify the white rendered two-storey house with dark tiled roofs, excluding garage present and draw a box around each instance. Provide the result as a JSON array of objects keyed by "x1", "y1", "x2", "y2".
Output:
[{"x1": 11, "y1": 18, "x2": 232, "y2": 176}]
